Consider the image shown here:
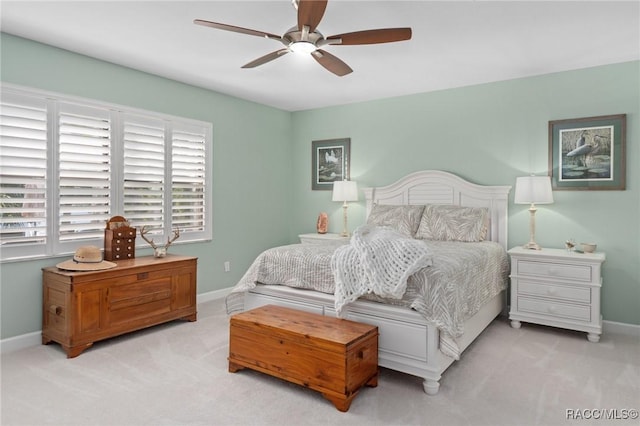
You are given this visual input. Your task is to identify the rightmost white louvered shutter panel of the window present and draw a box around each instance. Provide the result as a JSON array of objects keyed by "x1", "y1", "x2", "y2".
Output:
[{"x1": 171, "y1": 123, "x2": 207, "y2": 233}]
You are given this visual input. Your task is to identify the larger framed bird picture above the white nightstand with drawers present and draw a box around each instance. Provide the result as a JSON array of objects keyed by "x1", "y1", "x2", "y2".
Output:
[{"x1": 549, "y1": 114, "x2": 627, "y2": 190}]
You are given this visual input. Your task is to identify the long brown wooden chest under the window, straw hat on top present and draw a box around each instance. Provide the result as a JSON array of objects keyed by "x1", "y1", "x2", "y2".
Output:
[{"x1": 42, "y1": 255, "x2": 198, "y2": 358}]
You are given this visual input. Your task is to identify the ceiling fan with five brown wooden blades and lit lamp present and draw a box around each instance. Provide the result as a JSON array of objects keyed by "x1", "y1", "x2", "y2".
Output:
[{"x1": 193, "y1": 0, "x2": 411, "y2": 77}]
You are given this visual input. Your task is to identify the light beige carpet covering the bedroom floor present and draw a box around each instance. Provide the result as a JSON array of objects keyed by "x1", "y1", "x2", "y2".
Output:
[{"x1": 1, "y1": 301, "x2": 640, "y2": 426}]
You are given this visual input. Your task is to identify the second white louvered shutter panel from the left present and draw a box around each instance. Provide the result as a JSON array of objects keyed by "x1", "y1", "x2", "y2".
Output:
[{"x1": 58, "y1": 103, "x2": 111, "y2": 243}]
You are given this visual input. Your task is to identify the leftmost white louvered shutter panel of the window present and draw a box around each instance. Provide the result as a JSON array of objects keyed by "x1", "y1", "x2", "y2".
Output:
[{"x1": 0, "y1": 94, "x2": 48, "y2": 249}]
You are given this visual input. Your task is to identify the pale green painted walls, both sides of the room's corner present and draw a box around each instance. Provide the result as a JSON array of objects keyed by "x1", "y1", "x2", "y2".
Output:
[{"x1": 0, "y1": 34, "x2": 640, "y2": 339}]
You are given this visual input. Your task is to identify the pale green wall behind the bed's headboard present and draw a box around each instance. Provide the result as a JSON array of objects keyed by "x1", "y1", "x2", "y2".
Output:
[{"x1": 292, "y1": 62, "x2": 640, "y2": 324}]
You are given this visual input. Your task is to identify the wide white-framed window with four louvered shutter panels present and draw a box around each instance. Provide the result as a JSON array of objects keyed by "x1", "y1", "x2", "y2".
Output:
[{"x1": 0, "y1": 86, "x2": 212, "y2": 260}]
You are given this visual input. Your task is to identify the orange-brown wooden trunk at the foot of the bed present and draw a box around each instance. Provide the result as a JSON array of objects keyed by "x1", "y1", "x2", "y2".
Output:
[{"x1": 229, "y1": 305, "x2": 378, "y2": 411}]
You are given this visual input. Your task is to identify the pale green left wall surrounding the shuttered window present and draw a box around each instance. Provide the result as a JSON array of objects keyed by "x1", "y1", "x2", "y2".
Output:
[{"x1": 0, "y1": 33, "x2": 291, "y2": 339}]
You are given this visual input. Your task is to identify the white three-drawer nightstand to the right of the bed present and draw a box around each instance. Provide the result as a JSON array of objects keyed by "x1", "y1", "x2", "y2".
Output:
[{"x1": 509, "y1": 247, "x2": 605, "y2": 342}]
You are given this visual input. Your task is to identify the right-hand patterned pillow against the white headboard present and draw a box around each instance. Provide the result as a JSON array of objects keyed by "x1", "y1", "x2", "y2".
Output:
[{"x1": 416, "y1": 204, "x2": 489, "y2": 242}]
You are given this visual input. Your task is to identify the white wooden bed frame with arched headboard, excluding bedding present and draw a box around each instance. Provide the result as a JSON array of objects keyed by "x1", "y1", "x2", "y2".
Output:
[{"x1": 230, "y1": 170, "x2": 511, "y2": 395}]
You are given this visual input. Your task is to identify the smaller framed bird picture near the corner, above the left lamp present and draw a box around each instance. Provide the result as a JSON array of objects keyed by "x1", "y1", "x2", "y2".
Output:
[{"x1": 311, "y1": 138, "x2": 351, "y2": 190}]
